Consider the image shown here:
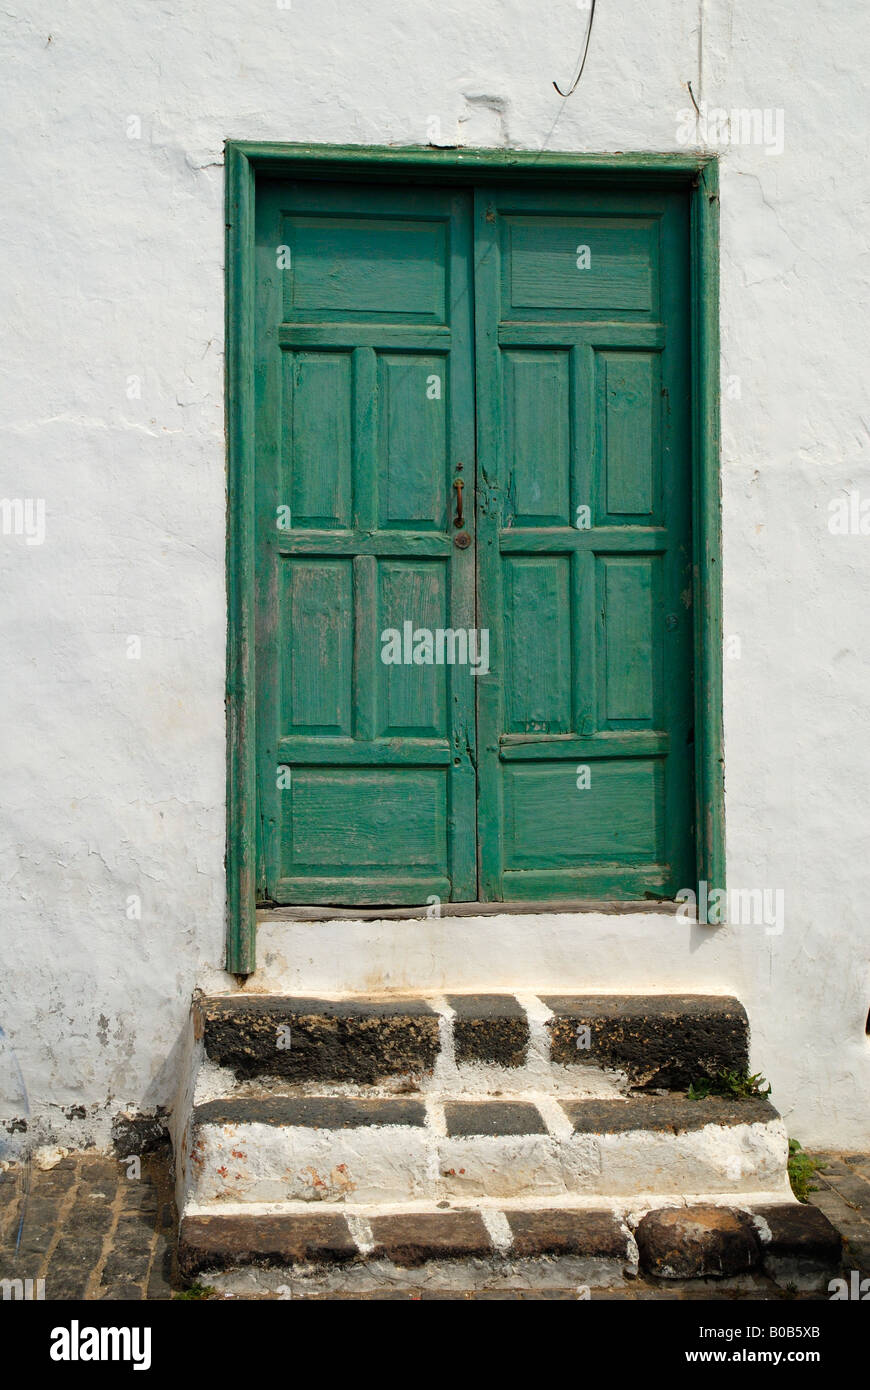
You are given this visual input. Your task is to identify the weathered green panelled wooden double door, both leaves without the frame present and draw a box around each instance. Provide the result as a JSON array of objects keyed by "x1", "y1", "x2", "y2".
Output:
[{"x1": 256, "y1": 182, "x2": 695, "y2": 905}]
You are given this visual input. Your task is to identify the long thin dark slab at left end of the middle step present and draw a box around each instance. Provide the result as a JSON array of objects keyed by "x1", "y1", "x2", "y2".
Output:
[{"x1": 193, "y1": 1095, "x2": 425, "y2": 1129}]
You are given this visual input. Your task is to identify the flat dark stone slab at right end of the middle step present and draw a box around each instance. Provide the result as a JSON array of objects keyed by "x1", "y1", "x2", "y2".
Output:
[{"x1": 559, "y1": 1095, "x2": 778, "y2": 1134}]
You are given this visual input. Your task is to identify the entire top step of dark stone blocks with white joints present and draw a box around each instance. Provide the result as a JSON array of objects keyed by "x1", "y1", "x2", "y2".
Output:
[{"x1": 196, "y1": 992, "x2": 749, "y2": 1094}]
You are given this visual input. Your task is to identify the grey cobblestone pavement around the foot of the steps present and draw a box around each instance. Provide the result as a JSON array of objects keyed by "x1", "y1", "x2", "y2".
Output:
[{"x1": 0, "y1": 1152, "x2": 870, "y2": 1302}]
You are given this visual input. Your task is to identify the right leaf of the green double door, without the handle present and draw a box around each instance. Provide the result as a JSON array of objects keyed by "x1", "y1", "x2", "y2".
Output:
[{"x1": 475, "y1": 188, "x2": 695, "y2": 901}]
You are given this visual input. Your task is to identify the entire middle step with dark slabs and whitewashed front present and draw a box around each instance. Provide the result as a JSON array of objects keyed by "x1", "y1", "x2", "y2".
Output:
[{"x1": 183, "y1": 1093, "x2": 789, "y2": 1205}]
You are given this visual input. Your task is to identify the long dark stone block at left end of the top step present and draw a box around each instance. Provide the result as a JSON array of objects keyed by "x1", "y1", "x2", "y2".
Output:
[{"x1": 199, "y1": 994, "x2": 439, "y2": 1084}]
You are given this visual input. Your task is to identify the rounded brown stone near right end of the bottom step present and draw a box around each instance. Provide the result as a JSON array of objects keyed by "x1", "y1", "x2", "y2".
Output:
[{"x1": 635, "y1": 1205, "x2": 762, "y2": 1279}]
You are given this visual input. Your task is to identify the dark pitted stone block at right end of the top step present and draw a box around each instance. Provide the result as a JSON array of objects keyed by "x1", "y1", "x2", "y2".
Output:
[{"x1": 542, "y1": 994, "x2": 749, "y2": 1090}]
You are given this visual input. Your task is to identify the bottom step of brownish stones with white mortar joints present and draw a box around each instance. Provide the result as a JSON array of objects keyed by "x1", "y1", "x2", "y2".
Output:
[{"x1": 179, "y1": 1201, "x2": 841, "y2": 1297}]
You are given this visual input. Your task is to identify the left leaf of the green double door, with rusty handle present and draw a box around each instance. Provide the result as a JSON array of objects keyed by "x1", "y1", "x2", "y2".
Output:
[{"x1": 256, "y1": 183, "x2": 477, "y2": 904}]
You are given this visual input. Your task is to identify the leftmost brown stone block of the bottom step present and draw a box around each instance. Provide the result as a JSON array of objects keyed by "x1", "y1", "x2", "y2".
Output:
[{"x1": 178, "y1": 1212, "x2": 357, "y2": 1276}]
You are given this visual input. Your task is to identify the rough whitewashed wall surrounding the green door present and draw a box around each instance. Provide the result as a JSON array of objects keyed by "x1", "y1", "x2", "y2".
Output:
[{"x1": 0, "y1": 0, "x2": 870, "y2": 1145}]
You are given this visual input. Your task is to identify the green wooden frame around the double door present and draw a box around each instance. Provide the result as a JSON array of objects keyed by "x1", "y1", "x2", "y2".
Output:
[{"x1": 225, "y1": 140, "x2": 725, "y2": 974}]
